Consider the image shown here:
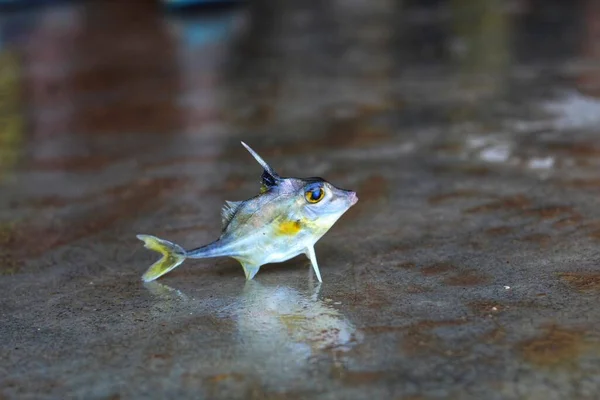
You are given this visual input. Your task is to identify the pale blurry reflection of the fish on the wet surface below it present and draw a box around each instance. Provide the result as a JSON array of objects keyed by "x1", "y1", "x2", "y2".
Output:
[{"x1": 144, "y1": 280, "x2": 363, "y2": 387}]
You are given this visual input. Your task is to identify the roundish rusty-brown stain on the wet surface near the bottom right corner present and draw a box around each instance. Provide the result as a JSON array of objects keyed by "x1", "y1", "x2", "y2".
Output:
[{"x1": 517, "y1": 325, "x2": 587, "y2": 367}]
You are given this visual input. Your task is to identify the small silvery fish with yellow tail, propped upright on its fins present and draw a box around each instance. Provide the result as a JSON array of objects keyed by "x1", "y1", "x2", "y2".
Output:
[{"x1": 137, "y1": 142, "x2": 358, "y2": 282}]
